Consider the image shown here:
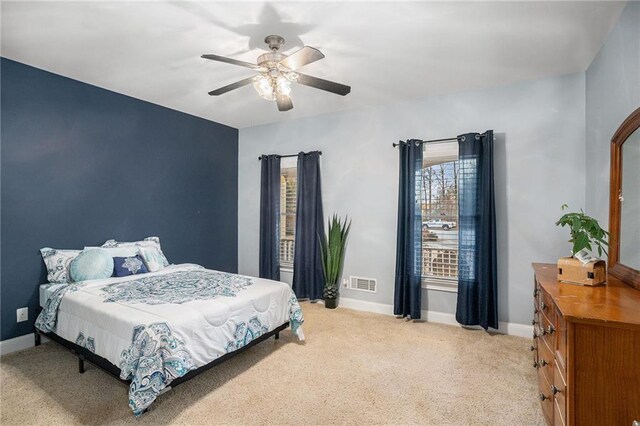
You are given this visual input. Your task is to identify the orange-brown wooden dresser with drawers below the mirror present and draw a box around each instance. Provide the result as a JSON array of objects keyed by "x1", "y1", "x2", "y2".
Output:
[{"x1": 531, "y1": 263, "x2": 640, "y2": 426}]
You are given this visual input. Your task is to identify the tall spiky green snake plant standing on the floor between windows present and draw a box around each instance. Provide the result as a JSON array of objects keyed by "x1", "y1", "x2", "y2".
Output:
[{"x1": 320, "y1": 214, "x2": 351, "y2": 309}]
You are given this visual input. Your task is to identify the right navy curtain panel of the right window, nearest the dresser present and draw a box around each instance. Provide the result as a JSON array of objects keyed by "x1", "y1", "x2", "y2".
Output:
[{"x1": 456, "y1": 130, "x2": 498, "y2": 330}]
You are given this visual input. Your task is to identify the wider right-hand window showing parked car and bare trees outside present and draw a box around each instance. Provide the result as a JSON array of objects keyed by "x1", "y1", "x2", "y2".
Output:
[{"x1": 419, "y1": 141, "x2": 460, "y2": 291}]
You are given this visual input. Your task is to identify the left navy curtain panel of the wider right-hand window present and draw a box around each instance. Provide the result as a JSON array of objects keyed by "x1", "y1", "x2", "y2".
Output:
[{"x1": 393, "y1": 139, "x2": 422, "y2": 319}]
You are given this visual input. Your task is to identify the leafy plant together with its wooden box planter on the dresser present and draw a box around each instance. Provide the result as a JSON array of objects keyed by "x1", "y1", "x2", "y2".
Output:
[{"x1": 556, "y1": 204, "x2": 609, "y2": 286}]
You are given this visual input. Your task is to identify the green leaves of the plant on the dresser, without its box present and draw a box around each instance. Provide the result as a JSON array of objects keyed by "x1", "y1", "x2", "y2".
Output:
[{"x1": 556, "y1": 204, "x2": 609, "y2": 256}]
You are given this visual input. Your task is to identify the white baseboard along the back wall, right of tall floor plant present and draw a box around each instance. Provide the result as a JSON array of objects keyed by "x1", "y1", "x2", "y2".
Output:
[{"x1": 338, "y1": 297, "x2": 533, "y2": 337}]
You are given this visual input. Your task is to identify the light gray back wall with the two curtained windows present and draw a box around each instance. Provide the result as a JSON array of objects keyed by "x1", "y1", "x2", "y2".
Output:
[{"x1": 238, "y1": 73, "x2": 585, "y2": 324}]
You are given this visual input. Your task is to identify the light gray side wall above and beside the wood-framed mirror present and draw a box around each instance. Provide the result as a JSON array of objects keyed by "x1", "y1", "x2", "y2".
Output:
[{"x1": 586, "y1": 1, "x2": 640, "y2": 228}]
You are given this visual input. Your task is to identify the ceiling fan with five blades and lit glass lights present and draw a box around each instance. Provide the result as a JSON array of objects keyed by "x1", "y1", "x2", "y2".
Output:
[{"x1": 202, "y1": 35, "x2": 351, "y2": 111}]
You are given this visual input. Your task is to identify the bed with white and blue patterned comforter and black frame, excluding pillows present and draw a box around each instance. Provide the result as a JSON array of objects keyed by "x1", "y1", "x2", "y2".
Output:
[{"x1": 36, "y1": 264, "x2": 304, "y2": 416}]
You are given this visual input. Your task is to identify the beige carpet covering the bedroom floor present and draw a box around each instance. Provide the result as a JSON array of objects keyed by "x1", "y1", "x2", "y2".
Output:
[{"x1": 0, "y1": 303, "x2": 544, "y2": 425}]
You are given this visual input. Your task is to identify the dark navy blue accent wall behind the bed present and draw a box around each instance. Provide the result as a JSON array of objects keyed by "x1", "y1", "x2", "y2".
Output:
[{"x1": 0, "y1": 58, "x2": 238, "y2": 340}]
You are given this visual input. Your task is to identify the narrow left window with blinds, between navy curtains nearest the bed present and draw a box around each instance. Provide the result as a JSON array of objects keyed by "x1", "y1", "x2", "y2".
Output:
[{"x1": 280, "y1": 157, "x2": 298, "y2": 268}]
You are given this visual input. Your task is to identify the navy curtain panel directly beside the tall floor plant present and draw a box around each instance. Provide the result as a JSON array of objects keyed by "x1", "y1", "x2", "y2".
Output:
[{"x1": 292, "y1": 151, "x2": 325, "y2": 300}]
